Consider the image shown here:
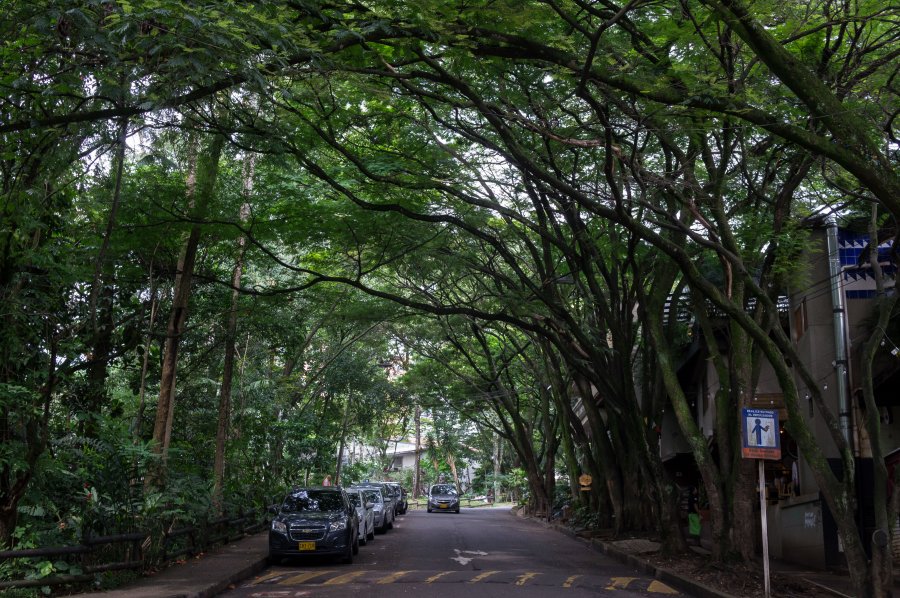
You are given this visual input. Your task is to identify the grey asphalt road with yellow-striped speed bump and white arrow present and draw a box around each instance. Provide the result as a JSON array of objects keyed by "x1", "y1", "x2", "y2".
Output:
[{"x1": 222, "y1": 508, "x2": 685, "y2": 598}]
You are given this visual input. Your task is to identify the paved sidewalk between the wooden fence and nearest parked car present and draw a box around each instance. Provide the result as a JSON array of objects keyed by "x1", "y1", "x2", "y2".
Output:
[{"x1": 79, "y1": 530, "x2": 269, "y2": 598}]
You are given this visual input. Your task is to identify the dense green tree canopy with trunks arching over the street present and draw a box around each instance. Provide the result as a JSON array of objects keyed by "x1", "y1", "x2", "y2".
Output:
[{"x1": 0, "y1": 0, "x2": 900, "y2": 593}]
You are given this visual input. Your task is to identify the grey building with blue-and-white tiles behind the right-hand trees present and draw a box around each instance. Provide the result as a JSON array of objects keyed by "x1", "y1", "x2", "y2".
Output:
[{"x1": 660, "y1": 221, "x2": 900, "y2": 569}]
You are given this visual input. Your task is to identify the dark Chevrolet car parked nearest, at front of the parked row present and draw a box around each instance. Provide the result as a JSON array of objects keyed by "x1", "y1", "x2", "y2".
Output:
[{"x1": 269, "y1": 486, "x2": 359, "y2": 563}]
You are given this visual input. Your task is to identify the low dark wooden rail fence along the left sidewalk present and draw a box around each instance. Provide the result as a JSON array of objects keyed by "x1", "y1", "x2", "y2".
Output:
[{"x1": 0, "y1": 511, "x2": 267, "y2": 590}]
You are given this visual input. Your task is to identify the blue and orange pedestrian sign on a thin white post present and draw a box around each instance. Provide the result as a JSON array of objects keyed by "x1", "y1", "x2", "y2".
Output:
[{"x1": 741, "y1": 409, "x2": 781, "y2": 598}]
